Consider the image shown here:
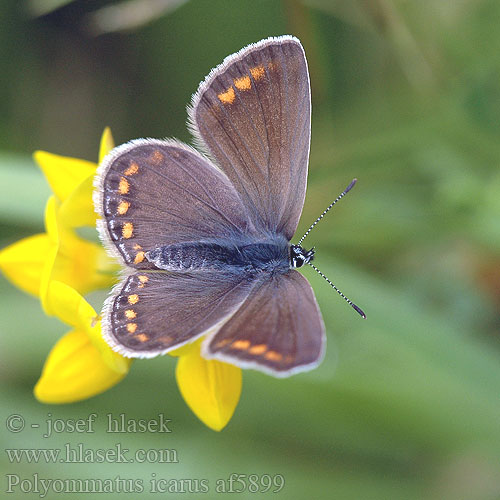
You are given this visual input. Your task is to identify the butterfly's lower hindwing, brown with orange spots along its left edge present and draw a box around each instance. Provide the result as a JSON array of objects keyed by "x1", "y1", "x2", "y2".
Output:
[{"x1": 102, "y1": 270, "x2": 255, "y2": 357}]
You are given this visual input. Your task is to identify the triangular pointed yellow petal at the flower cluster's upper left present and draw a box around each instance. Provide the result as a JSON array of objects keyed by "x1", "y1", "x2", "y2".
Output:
[{"x1": 33, "y1": 151, "x2": 97, "y2": 201}]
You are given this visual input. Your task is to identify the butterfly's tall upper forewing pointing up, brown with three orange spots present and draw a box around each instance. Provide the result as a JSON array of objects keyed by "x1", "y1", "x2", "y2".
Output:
[{"x1": 189, "y1": 36, "x2": 311, "y2": 240}]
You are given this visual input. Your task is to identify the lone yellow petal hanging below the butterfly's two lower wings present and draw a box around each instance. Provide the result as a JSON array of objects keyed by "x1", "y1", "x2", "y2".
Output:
[{"x1": 175, "y1": 341, "x2": 241, "y2": 431}]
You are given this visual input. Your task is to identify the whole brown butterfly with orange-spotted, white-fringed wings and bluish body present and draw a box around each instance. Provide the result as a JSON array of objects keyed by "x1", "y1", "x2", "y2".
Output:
[{"x1": 94, "y1": 36, "x2": 364, "y2": 377}]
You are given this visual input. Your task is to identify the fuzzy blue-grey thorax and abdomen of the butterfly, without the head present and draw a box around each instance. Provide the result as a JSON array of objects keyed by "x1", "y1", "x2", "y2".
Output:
[{"x1": 146, "y1": 235, "x2": 290, "y2": 273}]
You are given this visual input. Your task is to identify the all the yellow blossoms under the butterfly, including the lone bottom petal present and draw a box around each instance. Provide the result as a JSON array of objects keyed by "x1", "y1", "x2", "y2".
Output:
[{"x1": 0, "y1": 129, "x2": 242, "y2": 431}]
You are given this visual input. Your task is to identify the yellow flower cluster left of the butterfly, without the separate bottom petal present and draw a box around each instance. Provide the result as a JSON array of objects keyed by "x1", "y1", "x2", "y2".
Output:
[{"x1": 0, "y1": 129, "x2": 130, "y2": 403}]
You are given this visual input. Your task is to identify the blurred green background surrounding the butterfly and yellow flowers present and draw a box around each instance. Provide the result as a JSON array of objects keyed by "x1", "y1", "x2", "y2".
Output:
[{"x1": 0, "y1": 0, "x2": 500, "y2": 500}]
